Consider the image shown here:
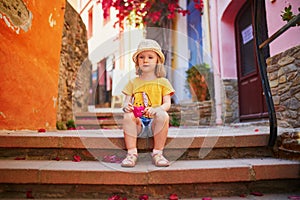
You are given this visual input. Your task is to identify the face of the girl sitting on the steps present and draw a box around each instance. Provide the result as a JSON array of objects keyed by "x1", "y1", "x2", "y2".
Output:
[{"x1": 137, "y1": 51, "x2": 158, "y2": 73}]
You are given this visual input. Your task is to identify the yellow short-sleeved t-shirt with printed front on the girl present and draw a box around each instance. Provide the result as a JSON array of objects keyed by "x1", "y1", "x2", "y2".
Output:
[{"x1": 123, "y1": 77, "x2": 175, "y2": 107}]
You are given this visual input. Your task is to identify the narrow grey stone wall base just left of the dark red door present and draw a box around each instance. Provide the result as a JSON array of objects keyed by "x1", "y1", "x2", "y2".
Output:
[{"x1": 222, "y1": 79, "x2": 239, "y2": 123}]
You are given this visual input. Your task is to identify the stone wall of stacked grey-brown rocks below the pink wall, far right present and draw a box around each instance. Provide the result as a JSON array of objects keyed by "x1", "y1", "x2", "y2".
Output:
[{"x1": 267, "y1": 46, "x2": 300, "y2": 128}]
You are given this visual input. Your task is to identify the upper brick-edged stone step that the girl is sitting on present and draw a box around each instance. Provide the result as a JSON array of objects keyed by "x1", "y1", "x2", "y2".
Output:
[{"x1": 0, "y1": 127, "x2": 274, "y2": 160}]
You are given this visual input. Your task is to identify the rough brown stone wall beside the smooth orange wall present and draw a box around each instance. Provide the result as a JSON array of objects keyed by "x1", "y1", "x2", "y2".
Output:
[{"x1": 57, "y1": 3, "x2": 91, "y2": 122}]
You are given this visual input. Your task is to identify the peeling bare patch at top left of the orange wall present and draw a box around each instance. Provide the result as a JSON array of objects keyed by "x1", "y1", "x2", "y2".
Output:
[{"x1": 0, "y1": 0, "x2": 33, "y2": 34}]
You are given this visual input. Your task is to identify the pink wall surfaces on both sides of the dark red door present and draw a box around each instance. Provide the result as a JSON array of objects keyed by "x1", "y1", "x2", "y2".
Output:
[{"x1": 210, "y1": 0, "x2": 300, "y2": 79}]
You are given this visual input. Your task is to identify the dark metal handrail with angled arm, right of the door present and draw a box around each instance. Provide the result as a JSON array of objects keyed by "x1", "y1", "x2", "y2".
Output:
[{"x1": 254, "y1": 0, "x2": 300, "y2": 147}]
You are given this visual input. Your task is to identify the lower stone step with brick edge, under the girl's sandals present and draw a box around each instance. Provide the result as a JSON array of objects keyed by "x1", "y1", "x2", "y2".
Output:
[{"x1": 0, "y1": 157, "x2": 300, "y2": 199}]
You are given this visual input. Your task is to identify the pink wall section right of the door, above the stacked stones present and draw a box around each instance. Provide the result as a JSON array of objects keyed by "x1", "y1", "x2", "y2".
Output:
[{"x1": 266, "y1": 0, "x2": 300, "y2": 56}]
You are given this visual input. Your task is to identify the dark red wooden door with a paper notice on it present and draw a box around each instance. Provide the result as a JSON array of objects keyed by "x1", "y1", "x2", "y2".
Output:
[{"x1": 235, "y1": 1, "x2": 268, "y2": 121}]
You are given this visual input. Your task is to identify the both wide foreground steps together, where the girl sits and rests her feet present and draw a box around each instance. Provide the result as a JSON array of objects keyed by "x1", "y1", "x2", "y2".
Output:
[{"x1": 0, "y1": 126, "x2": 300, "y2": 199}]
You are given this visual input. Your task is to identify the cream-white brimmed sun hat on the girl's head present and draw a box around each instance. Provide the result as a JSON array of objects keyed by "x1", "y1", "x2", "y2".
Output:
[{"x1": 132, "y1": 39, "x2": 165, "y2": 63}]
